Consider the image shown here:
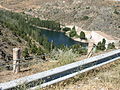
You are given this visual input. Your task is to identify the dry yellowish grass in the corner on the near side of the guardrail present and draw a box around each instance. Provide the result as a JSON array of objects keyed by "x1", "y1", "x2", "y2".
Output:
[{"x1": 42, "y1": 61, "x2": 120, "y2": 90}]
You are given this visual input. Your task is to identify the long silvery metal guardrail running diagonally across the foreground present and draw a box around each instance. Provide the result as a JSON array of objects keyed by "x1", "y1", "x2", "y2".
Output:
[{"x1": 0, "y1": 49, "x2": 120, "y2": 90}]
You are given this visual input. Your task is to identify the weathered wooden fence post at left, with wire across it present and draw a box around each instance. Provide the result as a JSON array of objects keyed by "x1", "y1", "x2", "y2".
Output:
[{"x1": 13, "y1": 48, "x2": 21, "y2": 73}]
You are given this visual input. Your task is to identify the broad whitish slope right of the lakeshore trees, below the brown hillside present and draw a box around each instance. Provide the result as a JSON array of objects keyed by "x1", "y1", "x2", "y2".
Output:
[{"x1": 89, "y1": 31, "x2": 120, "y2": 47}]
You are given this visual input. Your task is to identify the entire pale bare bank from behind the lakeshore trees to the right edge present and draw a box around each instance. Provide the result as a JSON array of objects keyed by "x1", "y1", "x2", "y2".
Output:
[{"x1": 66, "y1": 25, "x2": 120, "y2": 48}]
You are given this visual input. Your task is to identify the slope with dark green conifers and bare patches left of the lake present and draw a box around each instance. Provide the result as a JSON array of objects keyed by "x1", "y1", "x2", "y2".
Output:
[{"x1": 0, "y1": 9, "x2": 59, "y2": 65}]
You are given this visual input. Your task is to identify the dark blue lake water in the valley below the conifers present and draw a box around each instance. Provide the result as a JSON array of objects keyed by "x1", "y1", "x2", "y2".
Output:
[{"x1": 41, "y1": 30, "x2": 87, "y2": 47}]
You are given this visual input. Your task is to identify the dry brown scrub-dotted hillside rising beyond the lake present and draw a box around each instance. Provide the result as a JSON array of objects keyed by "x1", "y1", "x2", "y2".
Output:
[{"x1": 0, "y1": 0, "x2": 120, "y2": 37}]
